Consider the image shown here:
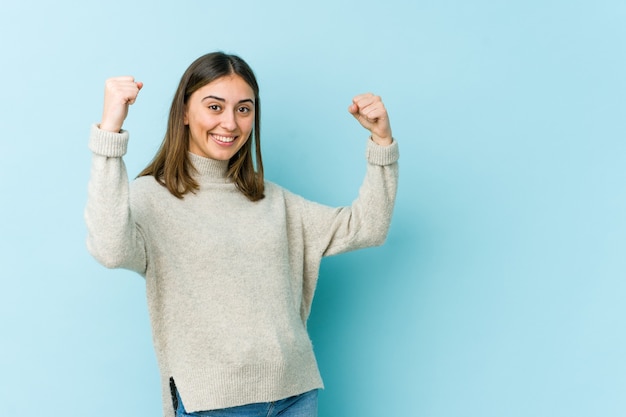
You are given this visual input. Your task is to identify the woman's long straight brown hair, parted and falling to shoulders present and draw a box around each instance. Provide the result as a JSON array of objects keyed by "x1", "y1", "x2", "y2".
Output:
[{"x1": 138, "y1": 52, "x2": 264, "y2": 201}]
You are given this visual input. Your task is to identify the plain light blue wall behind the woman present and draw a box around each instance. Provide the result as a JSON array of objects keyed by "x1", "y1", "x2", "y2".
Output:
[{"x1": 0, "y1": 0, "x2": 626, "y2": 417}]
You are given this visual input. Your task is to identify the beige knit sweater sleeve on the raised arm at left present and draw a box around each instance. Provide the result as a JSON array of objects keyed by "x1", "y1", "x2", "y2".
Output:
[{"x1": 85, "y1": 125, "x2": 146, "y2": 275}]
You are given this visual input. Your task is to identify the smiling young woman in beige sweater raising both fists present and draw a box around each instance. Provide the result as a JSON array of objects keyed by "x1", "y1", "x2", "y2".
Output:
[{"x1": 85, "y1": 52, "x2": 398, "y2": 417}]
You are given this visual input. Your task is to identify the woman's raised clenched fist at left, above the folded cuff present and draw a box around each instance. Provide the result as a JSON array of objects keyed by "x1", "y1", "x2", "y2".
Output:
[{"x1": 100, "y1": 76, "x2": 143, "y2": 133}]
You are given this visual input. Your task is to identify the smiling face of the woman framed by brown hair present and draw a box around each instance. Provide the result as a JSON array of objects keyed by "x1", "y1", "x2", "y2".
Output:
[{"x1": 184, "y1": 74, "x2": 255, "y2": 161}]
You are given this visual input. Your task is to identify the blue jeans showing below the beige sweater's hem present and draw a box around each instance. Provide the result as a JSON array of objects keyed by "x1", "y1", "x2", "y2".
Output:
[{"x1": 176, "y1": 389, "x2": 317, "y2": 417}]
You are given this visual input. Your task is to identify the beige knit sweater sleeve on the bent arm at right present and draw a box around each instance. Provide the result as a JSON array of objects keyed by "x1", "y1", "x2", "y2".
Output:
[{"x1": 288, "y1": 140, "x2": 399, "y2": 256}]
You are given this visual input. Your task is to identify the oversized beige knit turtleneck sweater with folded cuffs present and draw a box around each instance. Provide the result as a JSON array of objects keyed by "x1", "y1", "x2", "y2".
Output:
[{"x1": 85, "y1": 125, "x2": 398, "y2": 417}]
